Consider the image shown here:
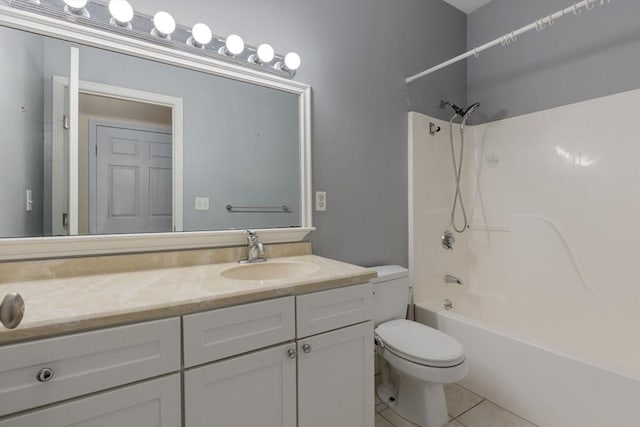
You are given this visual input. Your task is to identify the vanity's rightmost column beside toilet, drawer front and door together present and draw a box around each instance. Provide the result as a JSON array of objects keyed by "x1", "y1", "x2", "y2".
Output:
[{"x1": 296, "y1": 284, "x2": 375, "y2": 427}]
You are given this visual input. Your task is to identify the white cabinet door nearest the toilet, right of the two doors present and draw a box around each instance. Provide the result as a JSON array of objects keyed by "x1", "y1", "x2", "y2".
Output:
[{"x1": 298, "y1": 322, "x2": 374, "y2": 427}]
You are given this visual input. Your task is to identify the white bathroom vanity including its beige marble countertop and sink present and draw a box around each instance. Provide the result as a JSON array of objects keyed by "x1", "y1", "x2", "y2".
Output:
[{"x1": 0, "y1": 246, "x2": 375, "y2": 427}]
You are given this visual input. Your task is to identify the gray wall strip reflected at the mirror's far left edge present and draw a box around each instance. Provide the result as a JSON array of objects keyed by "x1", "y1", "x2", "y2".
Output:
[{"x1": 0, "y1": 27, "x2": 44, "y2": 237}]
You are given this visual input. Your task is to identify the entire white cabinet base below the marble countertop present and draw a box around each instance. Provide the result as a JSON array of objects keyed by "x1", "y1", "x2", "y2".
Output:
[{"x1": 0, "y1": 284, "x2": 374, "y2": 427}]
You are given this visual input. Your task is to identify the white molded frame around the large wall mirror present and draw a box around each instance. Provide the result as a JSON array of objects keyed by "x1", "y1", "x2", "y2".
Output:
[{"x1": 0, "y1": 5, "x2": 315, "y2": 261}]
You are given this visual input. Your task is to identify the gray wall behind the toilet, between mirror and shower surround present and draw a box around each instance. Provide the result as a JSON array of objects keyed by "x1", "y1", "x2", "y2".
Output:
[{"x1": 132, "y1": 0, "x2": 466, "y2": 265}]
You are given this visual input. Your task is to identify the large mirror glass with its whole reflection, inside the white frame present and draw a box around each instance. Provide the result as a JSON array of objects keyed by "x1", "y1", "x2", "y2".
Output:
[{"x1": 0, "y1": 23, "x2": 302, "y2": 237}]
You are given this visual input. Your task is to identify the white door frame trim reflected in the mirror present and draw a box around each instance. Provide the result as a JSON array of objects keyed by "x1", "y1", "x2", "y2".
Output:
[{"x1": 51, "y1": 76, "x2": 184, "y2": 233}]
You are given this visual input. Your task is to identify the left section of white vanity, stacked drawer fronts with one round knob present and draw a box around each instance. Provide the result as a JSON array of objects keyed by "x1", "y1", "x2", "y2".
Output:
[{"x1": 0, "y1": 318, "x2": 182, "y2": 427}]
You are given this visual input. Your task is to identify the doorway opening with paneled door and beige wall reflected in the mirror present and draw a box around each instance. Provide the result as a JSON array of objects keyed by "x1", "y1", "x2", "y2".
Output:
[{"x1": 78, "y1": 92, "x2": 173, "y2": 234}]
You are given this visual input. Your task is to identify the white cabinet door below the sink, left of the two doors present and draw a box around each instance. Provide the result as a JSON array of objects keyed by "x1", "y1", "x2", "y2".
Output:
[{"x1": 184, "y1": 343, "x2": 296, "y2": 427}]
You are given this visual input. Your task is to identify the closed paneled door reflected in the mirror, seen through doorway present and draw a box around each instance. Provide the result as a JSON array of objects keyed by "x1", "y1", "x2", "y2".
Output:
[{"x1": 89, "y1": 123, "x2": 173, "y2": 234}]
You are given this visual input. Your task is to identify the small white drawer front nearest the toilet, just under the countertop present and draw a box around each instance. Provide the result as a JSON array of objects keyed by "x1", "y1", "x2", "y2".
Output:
[{"x1": 296, "y1": 283, "x2": 373, "y2": 338}]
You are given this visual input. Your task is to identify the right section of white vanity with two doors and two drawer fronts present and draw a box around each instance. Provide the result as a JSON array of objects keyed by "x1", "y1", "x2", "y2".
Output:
[{"x1": 183, "y1": 284, "x2": 374, "y2": 427}]
